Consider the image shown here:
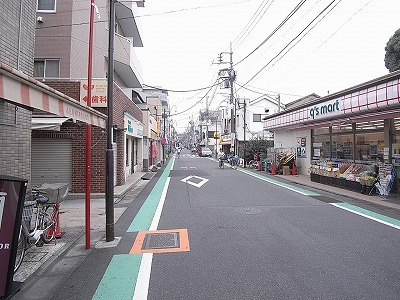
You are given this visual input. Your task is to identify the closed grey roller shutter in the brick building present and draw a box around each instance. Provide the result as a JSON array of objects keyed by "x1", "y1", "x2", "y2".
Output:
[{"x1": 32, "y1": 138, "x2": 72, "y2": 187}]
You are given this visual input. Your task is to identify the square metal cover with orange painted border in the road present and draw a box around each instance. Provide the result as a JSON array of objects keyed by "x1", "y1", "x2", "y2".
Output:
[{"x1": 129, "y1": 229, "x2": 190, "y2": 254}]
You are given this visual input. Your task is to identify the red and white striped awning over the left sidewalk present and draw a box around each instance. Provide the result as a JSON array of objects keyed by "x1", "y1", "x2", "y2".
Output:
[{"x1": 0, "y1": 63, "x2": 107, "y2": 128}]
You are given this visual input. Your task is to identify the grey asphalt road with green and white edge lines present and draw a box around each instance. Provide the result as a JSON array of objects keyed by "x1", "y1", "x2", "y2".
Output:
[{"x1": 8, "y1": 149, "x2": 400, "y2": 300}]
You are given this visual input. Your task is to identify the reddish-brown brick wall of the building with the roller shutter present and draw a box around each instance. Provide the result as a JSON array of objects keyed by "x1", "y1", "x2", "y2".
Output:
[{"x1": 37, "y1": 81, "x2": 143, "y2": 193}]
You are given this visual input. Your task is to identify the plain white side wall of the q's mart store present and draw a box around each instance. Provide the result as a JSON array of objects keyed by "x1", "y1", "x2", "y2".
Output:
[{"x1": 274, "y1": 129, "x2": 311, "y2": 174}]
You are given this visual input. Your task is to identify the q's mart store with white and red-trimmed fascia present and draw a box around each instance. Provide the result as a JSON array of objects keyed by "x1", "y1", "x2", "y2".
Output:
[{"x1": 264, "y1": 71, "x2": 400, "y2": 196}]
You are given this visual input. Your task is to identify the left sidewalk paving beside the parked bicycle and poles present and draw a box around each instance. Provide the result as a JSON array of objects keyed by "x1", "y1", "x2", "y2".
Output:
[{"x1": 12, "y1": 172, "x2": 156, "y2": 290}]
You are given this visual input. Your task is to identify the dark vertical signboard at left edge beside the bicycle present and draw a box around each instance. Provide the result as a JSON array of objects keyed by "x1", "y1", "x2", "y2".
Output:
[{"x1": 0, "y1": 175, "x2": 27, "y2": 298}]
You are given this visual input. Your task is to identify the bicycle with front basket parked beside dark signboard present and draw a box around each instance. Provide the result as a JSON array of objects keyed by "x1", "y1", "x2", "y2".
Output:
[{"x1": 14, "y1": 185, "x2": 68, "y2": 272}]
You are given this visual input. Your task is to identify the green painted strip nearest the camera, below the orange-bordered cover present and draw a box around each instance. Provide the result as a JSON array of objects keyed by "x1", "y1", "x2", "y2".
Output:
[{"x1": 92, "y1": 254, "x2": 142, "y2": 300}]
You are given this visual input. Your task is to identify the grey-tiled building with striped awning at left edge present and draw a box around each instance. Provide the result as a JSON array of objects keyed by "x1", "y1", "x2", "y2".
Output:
[{"x1": 0, "y1": 0, "x2": 107, "y2": 186}]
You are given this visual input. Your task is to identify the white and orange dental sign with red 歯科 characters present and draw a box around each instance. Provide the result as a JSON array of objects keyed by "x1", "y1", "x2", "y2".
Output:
[{"x1": 80, "y1": 79, "x2": 107, "y2": 107}]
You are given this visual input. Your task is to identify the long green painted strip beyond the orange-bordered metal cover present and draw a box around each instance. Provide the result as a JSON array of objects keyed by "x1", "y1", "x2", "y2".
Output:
[{"x1": 127, "y1": 158, "x2": 174, "y2": 232}]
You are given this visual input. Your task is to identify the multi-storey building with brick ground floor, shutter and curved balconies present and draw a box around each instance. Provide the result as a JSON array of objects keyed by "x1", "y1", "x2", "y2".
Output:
[{"x1": 32, "y1": 0, "x2": 144, "y2": 193}]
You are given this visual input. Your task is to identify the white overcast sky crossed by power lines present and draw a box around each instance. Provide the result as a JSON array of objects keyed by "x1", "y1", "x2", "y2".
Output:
[{"x1": 136, "y1": 0, "x2": 400, "y2": 132}]
